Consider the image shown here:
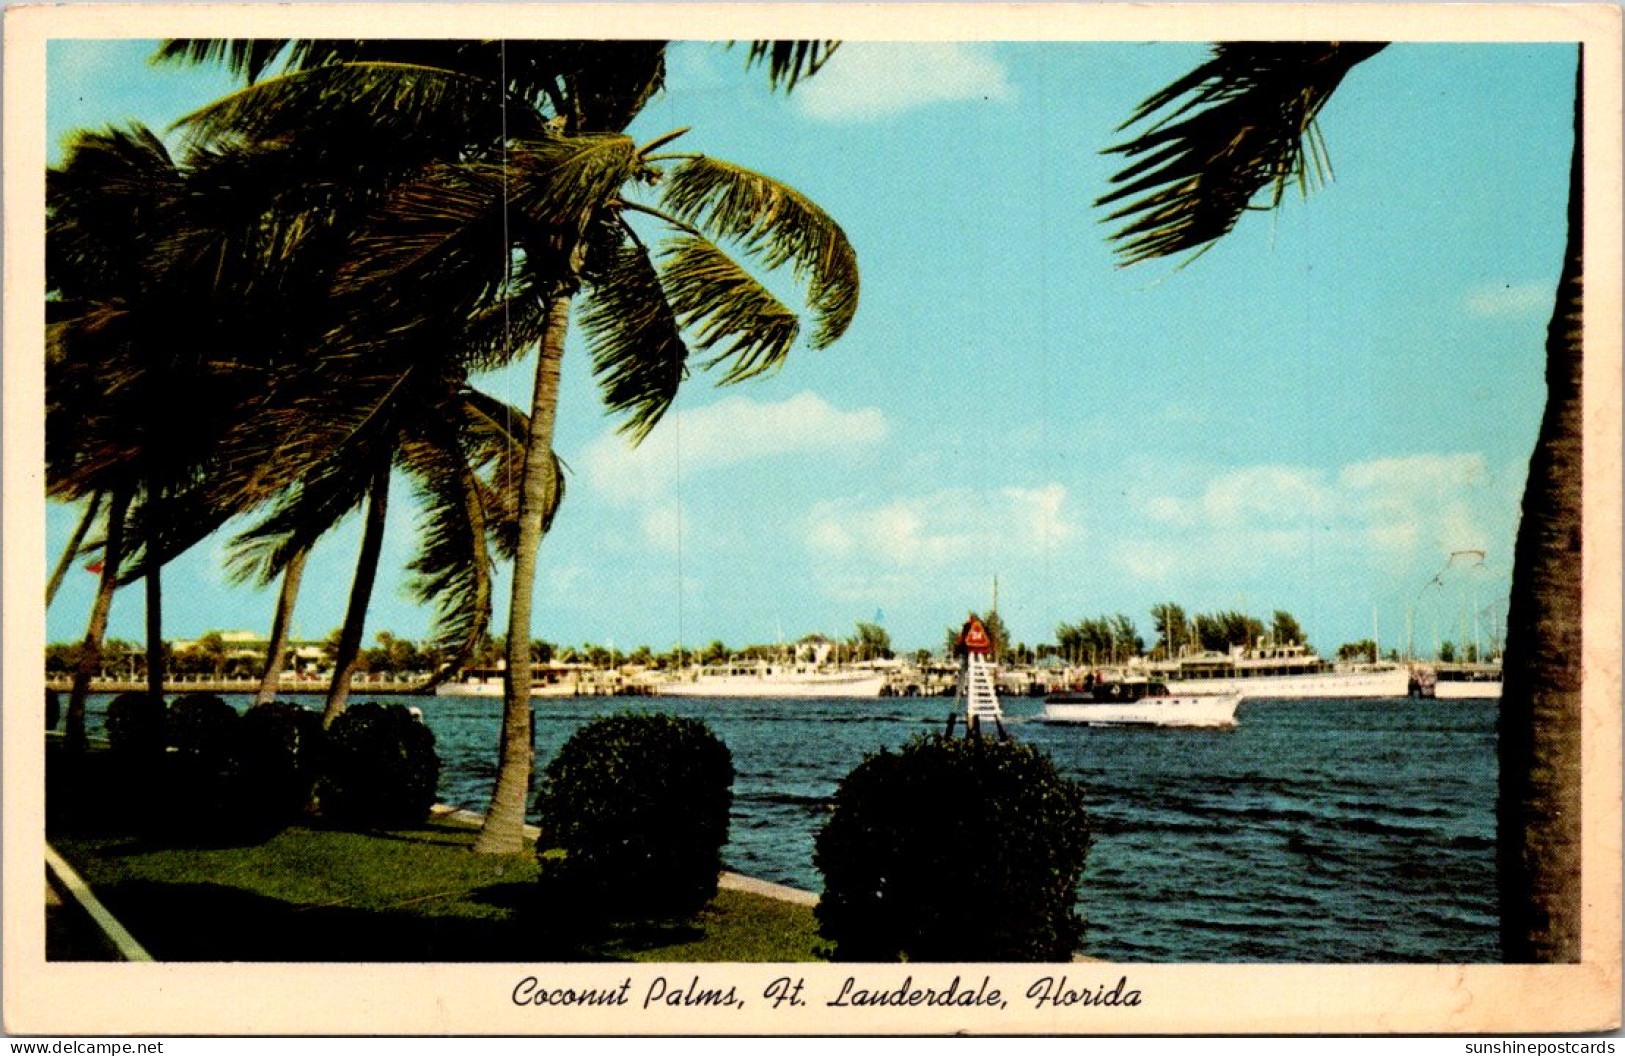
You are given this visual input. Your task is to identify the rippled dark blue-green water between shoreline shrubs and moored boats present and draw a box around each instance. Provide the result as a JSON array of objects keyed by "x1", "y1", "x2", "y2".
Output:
[{"x1": 79, "y1": 697, "x2": 1497, "y2": 963}]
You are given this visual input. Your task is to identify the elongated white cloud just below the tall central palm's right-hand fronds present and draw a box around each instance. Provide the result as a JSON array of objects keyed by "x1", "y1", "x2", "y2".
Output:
[{"x1": 580, "y1": 392, "x2": 889, "y2": 503}]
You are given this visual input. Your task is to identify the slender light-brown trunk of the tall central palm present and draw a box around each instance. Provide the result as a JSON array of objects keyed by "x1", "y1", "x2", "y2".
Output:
[{"x1": 475, "y1": 294, "x2": 570, "y2": 855}]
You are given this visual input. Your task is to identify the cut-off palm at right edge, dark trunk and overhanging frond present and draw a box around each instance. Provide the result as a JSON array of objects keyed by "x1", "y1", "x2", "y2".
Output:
[{"x1": 1099, "y1": 44, "x2": 1584, "y2": 962}]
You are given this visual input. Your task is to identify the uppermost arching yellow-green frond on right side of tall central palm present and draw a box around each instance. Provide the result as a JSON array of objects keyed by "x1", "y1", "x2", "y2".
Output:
[{"x1": 661, "y1": 158, "x2": 858, "y2": 348}]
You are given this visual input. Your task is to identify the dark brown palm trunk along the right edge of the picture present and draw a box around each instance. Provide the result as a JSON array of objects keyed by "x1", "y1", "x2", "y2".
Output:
[{"x1": 1497, "y1": 63, "x2": 1584, "y2": 963}]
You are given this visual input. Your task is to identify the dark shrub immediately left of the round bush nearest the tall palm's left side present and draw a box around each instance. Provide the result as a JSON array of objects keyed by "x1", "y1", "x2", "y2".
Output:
[{"x1": 242, "y1": 700, "x2": 323, "y2": 830}]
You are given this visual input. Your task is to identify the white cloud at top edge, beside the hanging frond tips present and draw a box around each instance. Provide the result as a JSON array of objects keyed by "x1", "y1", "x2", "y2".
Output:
[{"x1": 795, "y1": 42, "x2": 1016, "y2": 122}]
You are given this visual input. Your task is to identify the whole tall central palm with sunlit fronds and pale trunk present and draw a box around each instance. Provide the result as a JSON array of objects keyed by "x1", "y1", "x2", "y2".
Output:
[{"x1": 167, "y1": 41, "x2": 858, "y2": 853}]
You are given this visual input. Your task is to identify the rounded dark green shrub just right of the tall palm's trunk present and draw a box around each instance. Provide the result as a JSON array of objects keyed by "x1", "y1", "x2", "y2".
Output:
[{"x1": 536, "y1": 715, "x2": 733, "y2": 921}]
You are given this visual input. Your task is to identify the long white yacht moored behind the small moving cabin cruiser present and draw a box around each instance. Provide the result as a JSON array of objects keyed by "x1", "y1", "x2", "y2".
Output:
[{"x1": 1147, "y1": 645, "x2": 1411, "y2": 700}]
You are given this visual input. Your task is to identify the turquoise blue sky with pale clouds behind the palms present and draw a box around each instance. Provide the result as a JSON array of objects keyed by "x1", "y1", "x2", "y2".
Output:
[{"x1": 47, "y1": 41, "x2": 1575, "y2": 651}]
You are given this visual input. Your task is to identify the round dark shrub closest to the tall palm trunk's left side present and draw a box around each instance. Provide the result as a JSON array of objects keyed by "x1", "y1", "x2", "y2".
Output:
[{"x1": 317, "y1": 703, "x2": 440, "y2": 829}]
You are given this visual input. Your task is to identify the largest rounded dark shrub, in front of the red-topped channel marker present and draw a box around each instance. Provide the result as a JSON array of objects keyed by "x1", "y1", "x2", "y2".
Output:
[{"x1": 813, "y1": 736, "x2": 1089, "y2": 962}]
